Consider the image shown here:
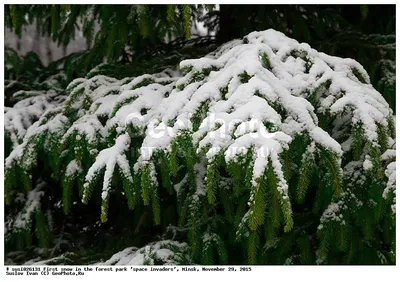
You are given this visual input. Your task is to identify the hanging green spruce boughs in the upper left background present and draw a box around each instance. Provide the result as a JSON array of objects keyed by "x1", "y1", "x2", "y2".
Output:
[{"x1": 5, "y1": 5, "x2": 214, "y2": 59}]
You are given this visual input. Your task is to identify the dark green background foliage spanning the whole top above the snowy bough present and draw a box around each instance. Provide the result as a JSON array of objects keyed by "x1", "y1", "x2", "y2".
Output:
[{"x1": 5, "y1": 5, "x2": 396, "y2": 110}]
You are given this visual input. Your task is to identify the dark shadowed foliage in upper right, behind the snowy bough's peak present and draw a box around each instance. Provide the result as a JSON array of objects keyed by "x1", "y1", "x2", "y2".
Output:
[{"x1": 214, "y1": 4, "x2": 396, "y2": 109}]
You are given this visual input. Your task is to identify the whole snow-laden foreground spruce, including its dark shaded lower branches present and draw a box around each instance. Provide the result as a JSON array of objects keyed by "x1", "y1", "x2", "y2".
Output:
[{"x1": 5, "y1": 30, "x2": 396, "y2": 264}]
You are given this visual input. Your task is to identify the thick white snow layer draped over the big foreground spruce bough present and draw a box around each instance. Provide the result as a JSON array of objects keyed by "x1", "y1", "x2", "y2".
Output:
[{"x1": 6, "y1": 30, "x2": 394, "y2": 214}]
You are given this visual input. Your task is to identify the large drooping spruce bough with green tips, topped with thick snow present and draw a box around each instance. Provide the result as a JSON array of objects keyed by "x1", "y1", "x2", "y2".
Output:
[{"x1": 5, "y1": 30, "x2": 395, "y2": 263}]
